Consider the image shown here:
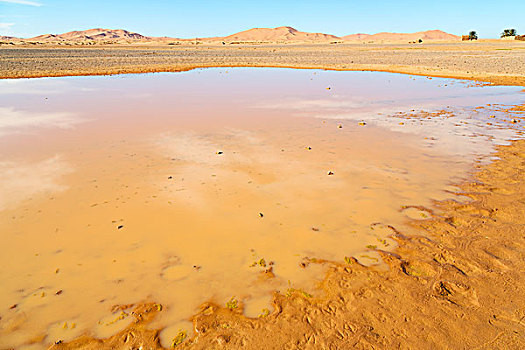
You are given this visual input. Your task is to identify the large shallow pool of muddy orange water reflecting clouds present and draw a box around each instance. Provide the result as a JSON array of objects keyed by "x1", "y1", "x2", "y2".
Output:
[{"x1": 0, "y1": 69, "x2": 523, "y2": 348}]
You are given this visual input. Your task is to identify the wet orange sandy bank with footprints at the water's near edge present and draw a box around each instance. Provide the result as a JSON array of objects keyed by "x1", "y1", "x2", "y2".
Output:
[{"x1": 52, "y1": 137, "x2": 525, "y2": 349}]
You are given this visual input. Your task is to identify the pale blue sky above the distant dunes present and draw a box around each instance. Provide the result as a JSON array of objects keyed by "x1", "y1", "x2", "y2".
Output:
[{"x1": 0, "y1": 0, "x2": 525, "y2": 38}]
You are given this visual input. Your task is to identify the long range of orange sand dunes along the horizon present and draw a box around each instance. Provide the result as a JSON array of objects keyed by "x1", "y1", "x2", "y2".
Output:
[{"x1": 0, "y1": 27, "x2": 460, "y2": 43}]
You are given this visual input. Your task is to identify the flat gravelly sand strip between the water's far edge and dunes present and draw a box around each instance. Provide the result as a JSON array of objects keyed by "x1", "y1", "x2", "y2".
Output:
[{"x1": 0, "y1": 40, "x2": 525, "y2": 86}]
